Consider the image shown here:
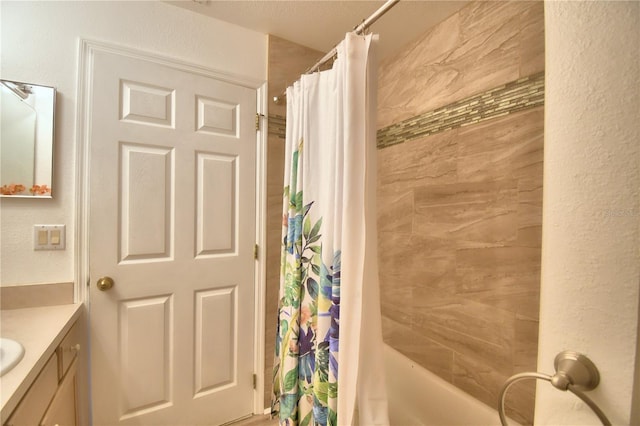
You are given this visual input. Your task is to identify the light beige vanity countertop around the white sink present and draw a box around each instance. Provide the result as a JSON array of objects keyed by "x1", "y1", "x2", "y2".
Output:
[{"x1": 0, "y1": 303, "x2": 82, "y2": 424}]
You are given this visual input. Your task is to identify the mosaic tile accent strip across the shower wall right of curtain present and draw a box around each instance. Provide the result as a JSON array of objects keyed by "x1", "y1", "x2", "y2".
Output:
[{"x1": 377, "y1": 72, "x2": 544, "y2": 149}]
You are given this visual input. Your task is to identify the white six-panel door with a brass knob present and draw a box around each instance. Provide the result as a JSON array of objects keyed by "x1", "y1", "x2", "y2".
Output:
[{"x1": 89, "y1": 51, "x2": 257, "y2": 425}]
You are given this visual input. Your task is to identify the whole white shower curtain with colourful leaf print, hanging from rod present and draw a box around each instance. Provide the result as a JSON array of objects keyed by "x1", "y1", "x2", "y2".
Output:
[{"x1": 271, "y1": 33, "x2": 388, "y2": 426}]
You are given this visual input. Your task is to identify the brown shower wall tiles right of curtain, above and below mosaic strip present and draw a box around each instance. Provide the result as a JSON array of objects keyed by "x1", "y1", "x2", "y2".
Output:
[{"x1": 378, "y1": 1, "x2": 544, "y2": 424}]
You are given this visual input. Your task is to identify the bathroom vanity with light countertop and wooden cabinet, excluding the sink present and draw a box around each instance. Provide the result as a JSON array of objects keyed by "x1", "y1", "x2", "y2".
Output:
[{"x1": 0, "y1": 304, "x2": 84, "y2": 426}]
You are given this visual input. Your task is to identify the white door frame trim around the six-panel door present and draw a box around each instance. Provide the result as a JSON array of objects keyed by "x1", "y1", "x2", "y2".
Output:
[{"x1": 74, "y1": 39, "x2": 268, "y2": 416}]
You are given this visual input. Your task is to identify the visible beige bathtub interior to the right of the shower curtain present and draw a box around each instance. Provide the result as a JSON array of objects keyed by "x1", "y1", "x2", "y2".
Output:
[{"x1": 384, "y1": 345, "x2": 518, "y2": 426}]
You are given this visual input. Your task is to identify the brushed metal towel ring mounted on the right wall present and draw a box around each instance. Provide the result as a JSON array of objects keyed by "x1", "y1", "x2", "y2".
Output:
[{"x1": 498, "y1": 351, "x2": 611, "y2": 426}]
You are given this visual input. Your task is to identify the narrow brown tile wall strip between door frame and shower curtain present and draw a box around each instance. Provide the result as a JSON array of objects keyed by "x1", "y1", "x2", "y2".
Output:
[{"x1": 264, "y1": 35, "x2": 324, "y2": 407}]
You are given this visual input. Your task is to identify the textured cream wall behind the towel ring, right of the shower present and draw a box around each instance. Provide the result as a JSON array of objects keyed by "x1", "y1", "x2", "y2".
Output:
[{"x1": 536, "y1": 1, "x2": 640, "y2": 425}]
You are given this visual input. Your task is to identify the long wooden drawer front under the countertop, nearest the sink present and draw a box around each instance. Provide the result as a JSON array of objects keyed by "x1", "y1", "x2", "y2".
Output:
[{"x1": 6, "y1": 353, "x2": 58, "y2": 426}]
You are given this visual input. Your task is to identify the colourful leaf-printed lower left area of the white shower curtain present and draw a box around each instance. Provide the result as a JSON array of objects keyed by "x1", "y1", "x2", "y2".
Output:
[{"x1": 271, "y1": 141, "x2": 340, "y2": 426}]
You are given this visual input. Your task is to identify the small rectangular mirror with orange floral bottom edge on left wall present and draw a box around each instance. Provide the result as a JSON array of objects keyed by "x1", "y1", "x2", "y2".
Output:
[{"x1": 0, "y1": 80, "x2": 56, "y2": 198}]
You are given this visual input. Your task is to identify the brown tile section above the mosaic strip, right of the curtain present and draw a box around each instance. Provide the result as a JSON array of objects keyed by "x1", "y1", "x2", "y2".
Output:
[{"x1": 378, "y1": 1, "x2": 544, "y2": 128}]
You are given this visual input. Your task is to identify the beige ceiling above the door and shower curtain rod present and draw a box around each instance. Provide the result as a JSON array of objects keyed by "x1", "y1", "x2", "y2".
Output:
[{"x1": 168, "y1": 0, "x2": 467, "y2": 61}]
